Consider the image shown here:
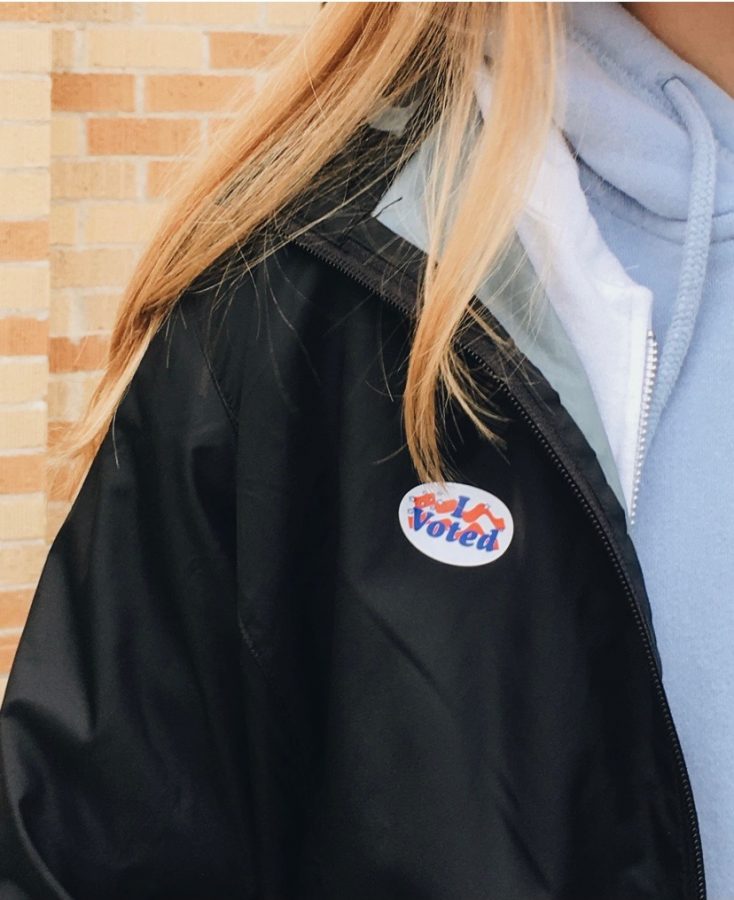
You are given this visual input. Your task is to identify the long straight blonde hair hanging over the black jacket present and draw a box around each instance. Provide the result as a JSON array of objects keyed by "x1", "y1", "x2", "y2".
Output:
[{"x1": 52, "y1": 2, "x2": 560, "y2": 500}]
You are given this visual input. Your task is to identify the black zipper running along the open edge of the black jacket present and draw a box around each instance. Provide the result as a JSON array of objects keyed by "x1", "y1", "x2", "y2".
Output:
[{"x1": 291, "y1": 235, "x2": 706, "y2": 900}]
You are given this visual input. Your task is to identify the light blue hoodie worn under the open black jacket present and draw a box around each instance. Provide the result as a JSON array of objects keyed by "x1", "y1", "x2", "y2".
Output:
[{"x1": 373, "y1": 3, "x2": 734, "y2": 900}]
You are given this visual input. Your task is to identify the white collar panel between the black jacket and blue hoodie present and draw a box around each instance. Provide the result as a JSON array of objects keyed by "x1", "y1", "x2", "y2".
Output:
[{"x1": 476, "y1": 70, "x2": 653, "y2": 511}]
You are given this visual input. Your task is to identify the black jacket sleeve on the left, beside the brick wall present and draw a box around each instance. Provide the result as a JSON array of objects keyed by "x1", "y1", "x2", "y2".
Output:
[{"x1": 0, "y1": 294, "x2": 264, "y2": 900}]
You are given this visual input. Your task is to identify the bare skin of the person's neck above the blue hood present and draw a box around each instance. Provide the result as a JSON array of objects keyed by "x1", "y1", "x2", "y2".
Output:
[{"x1": 622, "y1": 3, "x2": 734, "y2": 96}]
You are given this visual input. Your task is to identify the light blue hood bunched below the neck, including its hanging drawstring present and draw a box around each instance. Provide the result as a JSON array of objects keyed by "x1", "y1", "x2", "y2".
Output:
[{"x1": 557, "y1": 3, "x2": 734, "y2": 444}]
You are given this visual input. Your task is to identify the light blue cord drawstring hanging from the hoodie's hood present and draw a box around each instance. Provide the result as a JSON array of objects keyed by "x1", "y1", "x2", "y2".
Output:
[{"x1": 647, "y1": 76, "x2": 716, "y2": 448}]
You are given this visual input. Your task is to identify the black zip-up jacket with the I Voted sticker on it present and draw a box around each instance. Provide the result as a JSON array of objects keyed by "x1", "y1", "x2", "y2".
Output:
[{"x1": 0, "y1": 121, "x2": 705, "y2": 900}]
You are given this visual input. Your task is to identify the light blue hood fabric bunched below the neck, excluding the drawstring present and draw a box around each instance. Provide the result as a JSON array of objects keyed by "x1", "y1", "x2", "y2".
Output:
[{"x1": 556, "y1": 3, "x2": 734, "y2": 241}]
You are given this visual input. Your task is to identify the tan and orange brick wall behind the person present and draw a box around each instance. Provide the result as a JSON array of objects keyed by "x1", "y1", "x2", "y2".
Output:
[{"x1": 0, "y1": 2, "x2": 320, "y2": 694}]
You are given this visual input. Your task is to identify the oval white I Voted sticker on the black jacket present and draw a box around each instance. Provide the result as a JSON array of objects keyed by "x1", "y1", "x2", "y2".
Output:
[{"x1": 398, "y1": 481, "x2": 514, "y2": 566}]
